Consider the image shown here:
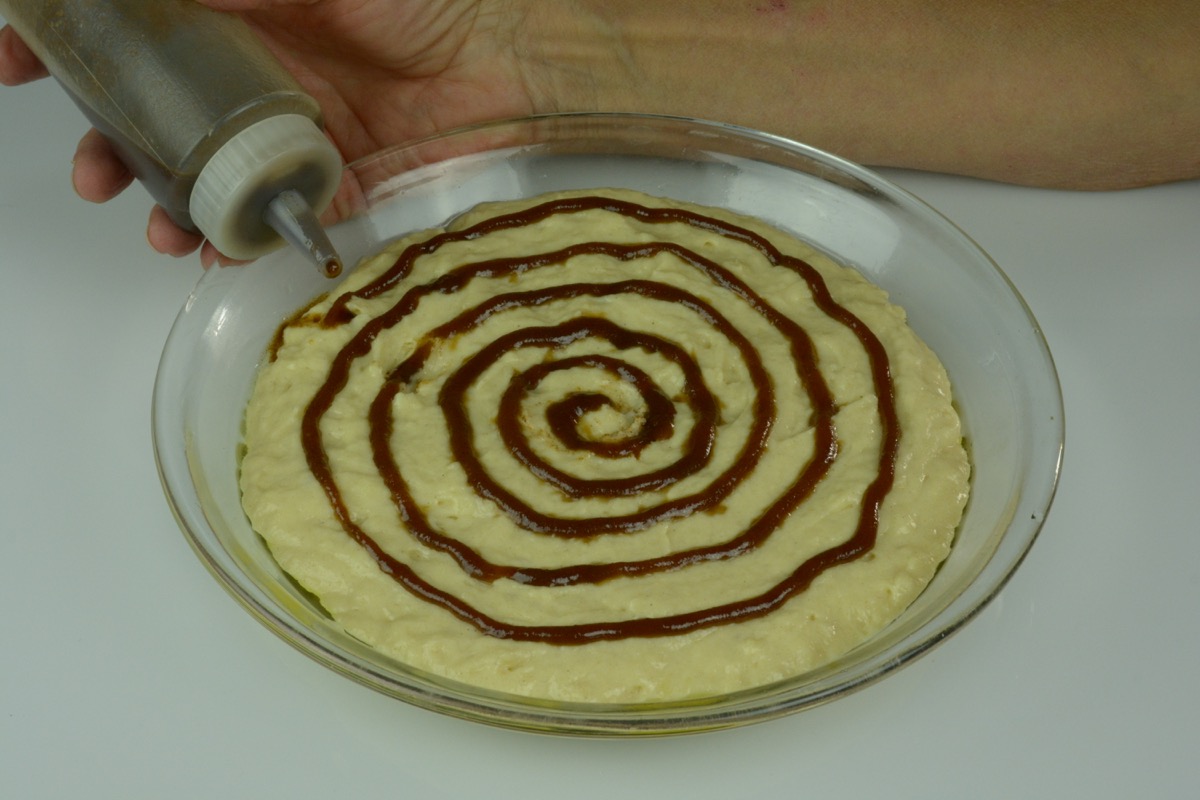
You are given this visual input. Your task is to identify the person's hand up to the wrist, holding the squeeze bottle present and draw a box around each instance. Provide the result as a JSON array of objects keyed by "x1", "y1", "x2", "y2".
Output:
[{"x1": 0, "y1": 0, "x2": 539, "y2": 266}]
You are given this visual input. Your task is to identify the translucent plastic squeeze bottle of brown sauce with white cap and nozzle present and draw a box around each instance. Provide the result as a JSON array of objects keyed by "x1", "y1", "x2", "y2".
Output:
[{"x1": 0, "y1": 0, "x2": 342, "y2": 277}]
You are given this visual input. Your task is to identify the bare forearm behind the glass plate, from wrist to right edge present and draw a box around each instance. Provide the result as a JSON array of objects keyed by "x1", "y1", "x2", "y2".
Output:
[{"x1": 525, "y1": 0, "x2": 1200, "y2": 188}]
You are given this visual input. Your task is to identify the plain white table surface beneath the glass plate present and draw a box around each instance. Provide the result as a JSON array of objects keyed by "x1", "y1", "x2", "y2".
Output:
[{"x1": 0, "y1": 61, "x2": 1200, "y2": 800}]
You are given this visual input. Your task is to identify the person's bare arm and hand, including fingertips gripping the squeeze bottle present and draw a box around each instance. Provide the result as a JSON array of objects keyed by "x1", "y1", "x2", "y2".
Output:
[{"x1": 0, "y1": 0, "x2": 1200, "y2": 264}]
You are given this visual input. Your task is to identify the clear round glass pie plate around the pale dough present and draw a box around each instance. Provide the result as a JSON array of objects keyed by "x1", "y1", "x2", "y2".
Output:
[{"x1": 154, "y1": 114, "x2": 1063, "y2": 735}]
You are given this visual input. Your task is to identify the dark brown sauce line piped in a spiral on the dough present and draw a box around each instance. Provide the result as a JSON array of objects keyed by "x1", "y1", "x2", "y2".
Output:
[{"x1": 288, "y1": 197, "x2": 900, "y2": 645}]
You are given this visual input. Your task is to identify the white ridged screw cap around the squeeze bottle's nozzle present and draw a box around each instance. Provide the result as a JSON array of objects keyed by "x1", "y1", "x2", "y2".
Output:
[{"x1": 188, "y1": 114, "x2": 342, "y2": 259}]
